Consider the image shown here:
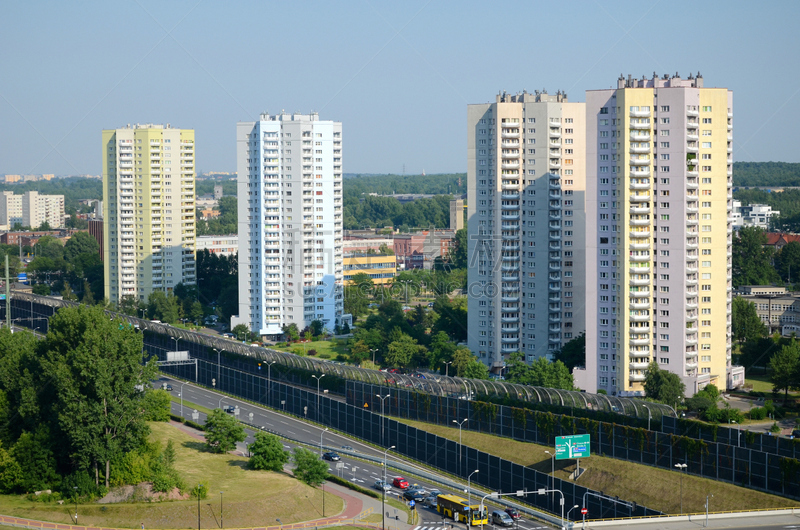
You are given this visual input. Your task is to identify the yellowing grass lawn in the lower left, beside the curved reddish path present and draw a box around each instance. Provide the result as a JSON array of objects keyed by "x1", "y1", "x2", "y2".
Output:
[{"x1": 0, "y1": 423, "x2": 343, "y2": 528}]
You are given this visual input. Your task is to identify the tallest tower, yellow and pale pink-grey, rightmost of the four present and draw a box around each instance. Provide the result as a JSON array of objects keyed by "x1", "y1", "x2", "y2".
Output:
[{"x1": 576, "y1": 74, "x2": 733, "y2": 395}]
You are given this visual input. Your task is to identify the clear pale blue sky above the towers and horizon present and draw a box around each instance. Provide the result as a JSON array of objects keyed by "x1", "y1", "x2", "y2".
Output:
[{"x1": 0, "y1": 0, "x2": 800, "y2": 174}]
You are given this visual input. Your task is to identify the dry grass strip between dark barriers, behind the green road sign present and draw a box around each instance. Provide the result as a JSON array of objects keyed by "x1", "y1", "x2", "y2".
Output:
[{"x1": 395, "y1": 418, "x2": 800, "y2": 513}]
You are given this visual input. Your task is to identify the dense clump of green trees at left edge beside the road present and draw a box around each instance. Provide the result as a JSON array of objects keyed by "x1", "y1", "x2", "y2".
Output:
[{"x1": 0, "y1": 305, "x2": 169, "y2": 493}]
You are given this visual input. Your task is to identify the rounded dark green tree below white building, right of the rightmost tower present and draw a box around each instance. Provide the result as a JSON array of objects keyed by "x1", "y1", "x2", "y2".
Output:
[{"x1": 733, "y1": 226, "x2": 779, "y2": 287}]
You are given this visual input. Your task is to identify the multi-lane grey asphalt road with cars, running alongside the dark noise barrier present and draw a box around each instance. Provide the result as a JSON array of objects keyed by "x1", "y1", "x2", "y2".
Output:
[{"x1": 153, "y1": 376, "x2": 551, "y2": 530}]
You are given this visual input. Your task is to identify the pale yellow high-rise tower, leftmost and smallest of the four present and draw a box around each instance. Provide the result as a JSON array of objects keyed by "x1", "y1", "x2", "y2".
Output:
[{"x1": 103, "y1": 124, "x2": 196, "y2": 303}]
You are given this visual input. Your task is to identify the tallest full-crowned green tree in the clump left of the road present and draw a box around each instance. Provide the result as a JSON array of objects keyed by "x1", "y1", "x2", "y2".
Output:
[{"x1": 38, "y1": 305, "x2": 158, "y2": 487}]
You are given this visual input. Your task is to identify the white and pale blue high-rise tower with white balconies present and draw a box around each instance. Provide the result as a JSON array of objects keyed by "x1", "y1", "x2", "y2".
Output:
[{"x1": 231, "y1": 113, "x2": 344, "y2": 337}]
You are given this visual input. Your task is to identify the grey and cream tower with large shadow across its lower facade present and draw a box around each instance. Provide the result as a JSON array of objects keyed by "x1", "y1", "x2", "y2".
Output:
[{"x1": 467, "y1": 91, "x2": 586, "y2": 371}]
